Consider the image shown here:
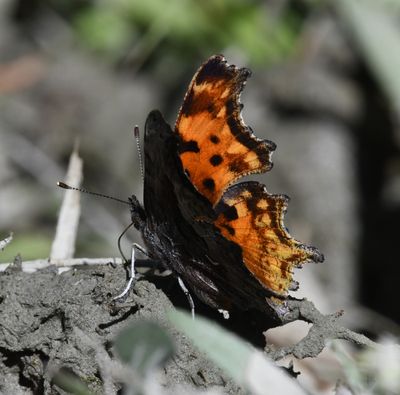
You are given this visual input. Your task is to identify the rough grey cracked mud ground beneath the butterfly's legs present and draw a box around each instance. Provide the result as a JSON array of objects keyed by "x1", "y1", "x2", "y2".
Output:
[{"x1": 0, "y1": 265, "x2": 244, "y2": 395}]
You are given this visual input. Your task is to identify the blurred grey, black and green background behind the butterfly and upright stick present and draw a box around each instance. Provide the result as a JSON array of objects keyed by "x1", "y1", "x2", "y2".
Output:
[{"x1": 0, "y1": 0, "x2": 400, "y2": 335}]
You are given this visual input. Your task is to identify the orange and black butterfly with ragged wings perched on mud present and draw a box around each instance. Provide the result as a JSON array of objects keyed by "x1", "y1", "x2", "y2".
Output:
[{"x1": 129, "y1": 55, "x2": 324, "y2": 320}]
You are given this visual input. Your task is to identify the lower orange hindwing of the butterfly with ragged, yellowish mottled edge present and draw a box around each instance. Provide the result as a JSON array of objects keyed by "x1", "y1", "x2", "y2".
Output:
[{"x1": 215, "y1": 181, "x2": 323, "y2": 297}]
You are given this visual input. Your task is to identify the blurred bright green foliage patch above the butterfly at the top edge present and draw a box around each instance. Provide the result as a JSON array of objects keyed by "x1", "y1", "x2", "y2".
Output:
[{"x1": 74, "y1": 0, "x2": 303, "y2": 65}]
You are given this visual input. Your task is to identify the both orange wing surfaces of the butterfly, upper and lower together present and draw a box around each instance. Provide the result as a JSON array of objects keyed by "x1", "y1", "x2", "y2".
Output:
[{"x1": 175, "y1": 55, "x2": 324, "y2": 298}]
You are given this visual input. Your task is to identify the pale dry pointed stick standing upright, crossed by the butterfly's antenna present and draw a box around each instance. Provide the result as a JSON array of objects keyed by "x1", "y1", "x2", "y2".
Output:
[{"x1": 50, "y1": 144, "x2": 82, "y2": 265}]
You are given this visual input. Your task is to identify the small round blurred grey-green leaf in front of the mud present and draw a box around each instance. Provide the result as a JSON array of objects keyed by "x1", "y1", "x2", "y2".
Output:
[{"x1": 115, "y1": 320, "x2": 175, "y2": 375}]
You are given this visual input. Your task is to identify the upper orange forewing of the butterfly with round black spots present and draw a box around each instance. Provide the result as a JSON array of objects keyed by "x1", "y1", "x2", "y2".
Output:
[{"x1": 175, "y1": 55, "x2": 275, "y2": 205}]
